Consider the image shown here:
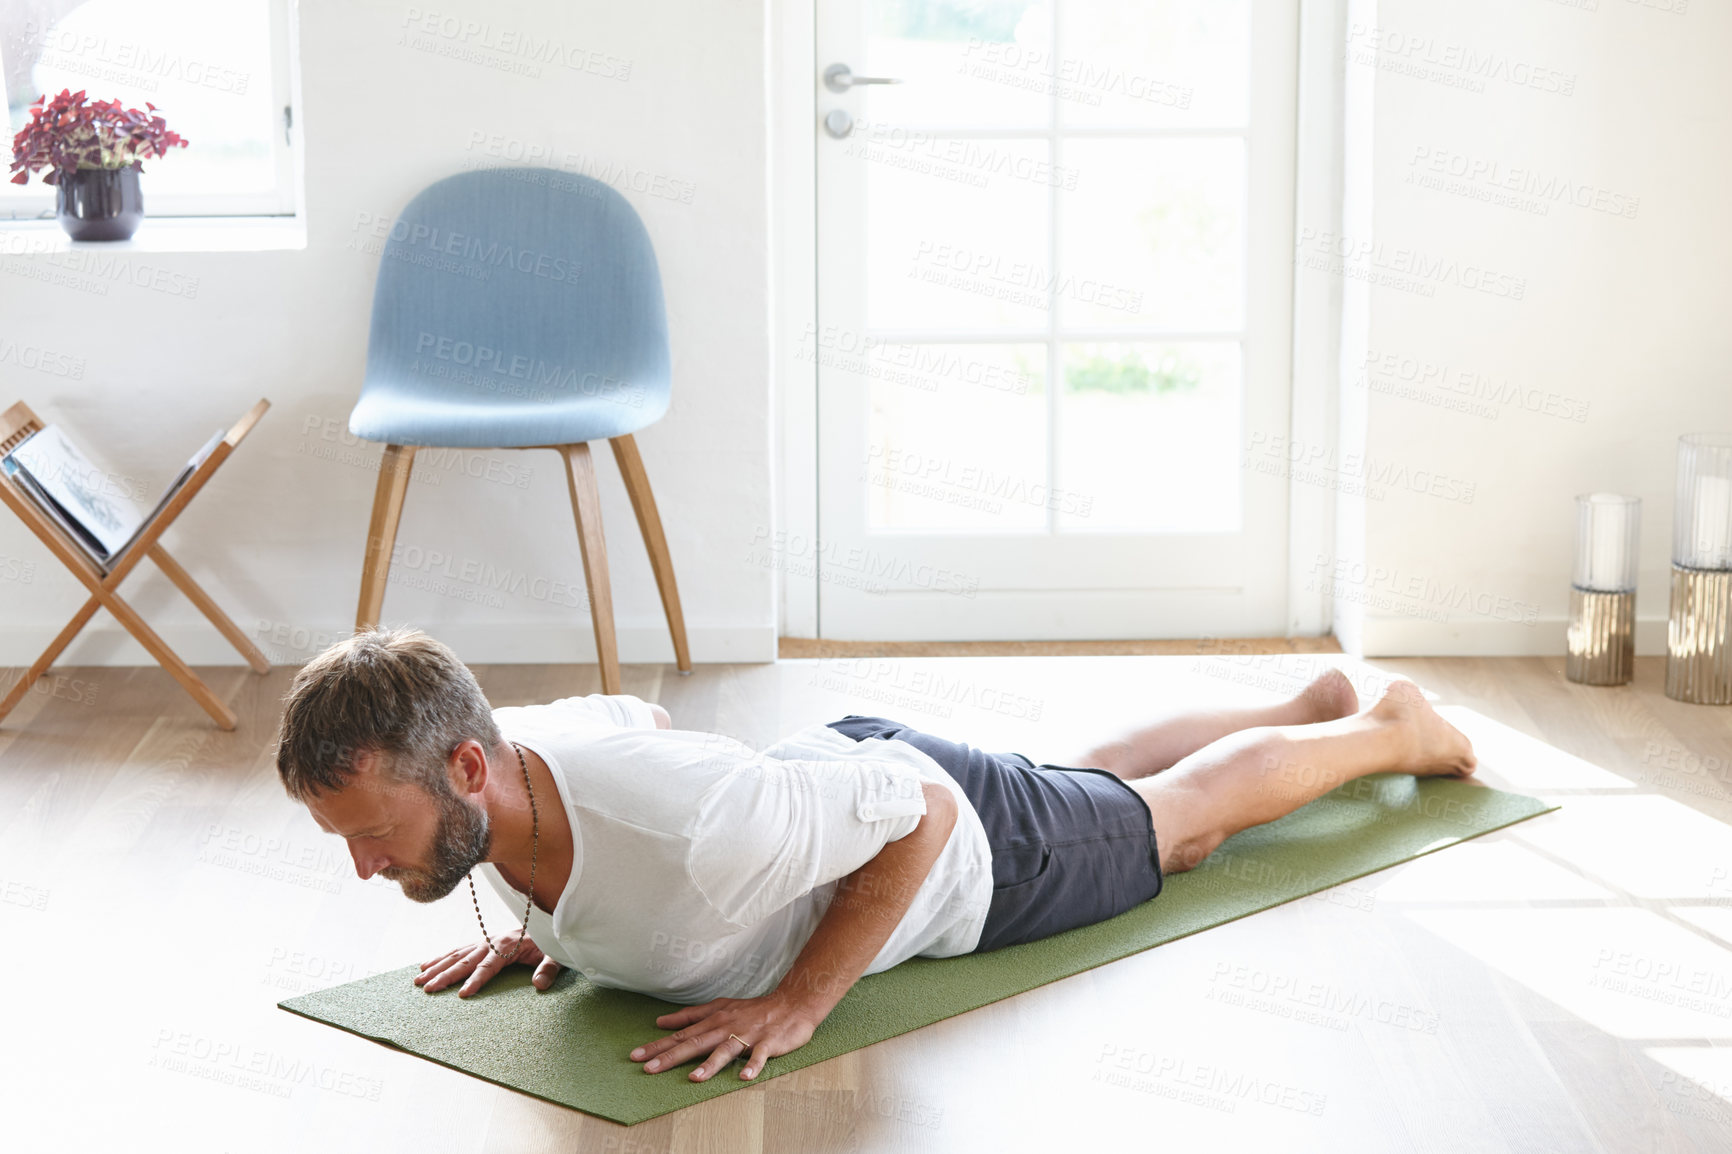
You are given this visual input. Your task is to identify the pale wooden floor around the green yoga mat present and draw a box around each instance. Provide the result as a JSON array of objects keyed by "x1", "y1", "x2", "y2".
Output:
[{"x1": 0, "y1": 652, "x2": 1732, "y2": 1154}]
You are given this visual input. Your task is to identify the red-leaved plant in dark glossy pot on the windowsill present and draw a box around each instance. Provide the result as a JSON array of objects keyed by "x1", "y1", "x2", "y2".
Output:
[{"x1": 12, "y1": 88, "x2": 187, "y2": 241}]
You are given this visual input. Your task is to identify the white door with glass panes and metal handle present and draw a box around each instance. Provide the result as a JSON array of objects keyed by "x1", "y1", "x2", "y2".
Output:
[{"x1": 817, "y1": 0, "x2": 1297, "y2": 639}]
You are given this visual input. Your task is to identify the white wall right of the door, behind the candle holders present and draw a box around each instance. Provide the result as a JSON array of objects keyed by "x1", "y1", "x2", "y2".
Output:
[{"x1": 1335, "y1": 0, "x2": 1732, "y2": 655}]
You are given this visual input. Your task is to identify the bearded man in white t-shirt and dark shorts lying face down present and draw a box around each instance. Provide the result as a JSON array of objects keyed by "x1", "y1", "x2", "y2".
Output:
[{"x1": 277, "y1": 629, "x2": 1474, "y2": 1081}]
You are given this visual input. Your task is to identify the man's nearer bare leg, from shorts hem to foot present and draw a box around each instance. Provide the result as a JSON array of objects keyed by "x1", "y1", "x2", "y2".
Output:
[{"x1": 1129, "y1": 681, "x2": 1476, "y2": 873}]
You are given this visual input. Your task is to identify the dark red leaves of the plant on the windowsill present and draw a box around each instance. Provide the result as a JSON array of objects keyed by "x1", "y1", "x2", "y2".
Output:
[{"x1": 12, "y1": 88, "x2": 187, "y2": 184}]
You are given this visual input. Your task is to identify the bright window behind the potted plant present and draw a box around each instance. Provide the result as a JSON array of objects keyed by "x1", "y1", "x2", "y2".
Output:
[{"x1": 0, "y1": 0, "x2": 298, "y2": 220}]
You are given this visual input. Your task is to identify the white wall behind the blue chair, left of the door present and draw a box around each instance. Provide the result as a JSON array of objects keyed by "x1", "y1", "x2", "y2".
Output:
[{"x1": 0, "y1": 0, "x2": 776, "y2": 665}]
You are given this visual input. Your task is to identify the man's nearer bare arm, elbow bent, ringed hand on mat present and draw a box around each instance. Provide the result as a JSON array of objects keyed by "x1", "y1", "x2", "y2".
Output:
[{"x1": 630, "y1": 783, "x2": 956, "y2": 1081}]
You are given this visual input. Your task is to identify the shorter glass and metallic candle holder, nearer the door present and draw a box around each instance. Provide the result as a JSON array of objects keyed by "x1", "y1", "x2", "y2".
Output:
[{"x1": 1564, "y1": 492, "x2": 1642, "y2": 684}]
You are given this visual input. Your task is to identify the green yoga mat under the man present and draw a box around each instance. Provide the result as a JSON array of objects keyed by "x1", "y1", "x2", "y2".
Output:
[{"x1": 279, "y1": 775, "x2": 1555, "y2": 1125}]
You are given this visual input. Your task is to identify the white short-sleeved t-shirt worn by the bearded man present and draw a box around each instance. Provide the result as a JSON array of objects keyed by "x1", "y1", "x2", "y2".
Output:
[{"x1": 480, "y1": 693, "x2": 992, "y2": 1003}]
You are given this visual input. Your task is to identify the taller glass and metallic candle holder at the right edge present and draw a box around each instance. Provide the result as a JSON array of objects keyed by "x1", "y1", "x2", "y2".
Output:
[{"x1": 1666, "y1": 433, "x2": 1732, "y2": 705}]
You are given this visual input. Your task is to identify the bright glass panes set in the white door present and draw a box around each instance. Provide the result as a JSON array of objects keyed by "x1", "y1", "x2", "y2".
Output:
[{"x1": 845, "y1": 0, "x2": 1253, "y2": 534}]
